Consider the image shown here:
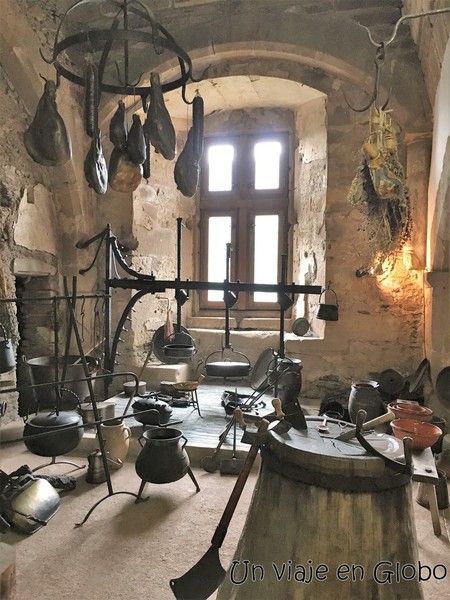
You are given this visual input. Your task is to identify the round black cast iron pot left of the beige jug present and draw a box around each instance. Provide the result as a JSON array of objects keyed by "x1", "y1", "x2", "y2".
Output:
[{"x1": 23, "y1": 411, "x2": 84, "y2": 457}]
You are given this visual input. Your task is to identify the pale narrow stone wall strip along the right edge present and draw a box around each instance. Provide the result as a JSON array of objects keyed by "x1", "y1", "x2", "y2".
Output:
[{"x1": 404, "y1": 0, "x2": 450, "y2": 419}]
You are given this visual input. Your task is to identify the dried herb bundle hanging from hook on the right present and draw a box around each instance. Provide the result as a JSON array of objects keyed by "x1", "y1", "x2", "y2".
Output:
[{"x1": 348, "y1": 108, "x2": 412, "y2": 266}]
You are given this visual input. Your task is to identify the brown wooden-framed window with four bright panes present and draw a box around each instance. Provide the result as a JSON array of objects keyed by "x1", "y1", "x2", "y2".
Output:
[{"x1": 200, "y1": 132, "x2": 290, "y2": 315}]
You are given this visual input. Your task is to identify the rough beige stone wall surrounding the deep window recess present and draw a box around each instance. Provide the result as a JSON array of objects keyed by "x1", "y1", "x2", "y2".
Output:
[{"x1": 0, "y1": 0, "x2": 448, "y2": 422}]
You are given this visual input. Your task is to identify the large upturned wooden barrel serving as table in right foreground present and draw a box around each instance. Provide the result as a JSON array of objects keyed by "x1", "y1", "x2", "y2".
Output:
[{"x1": 217, "y1": 417, "x2": 423, "y2": 600}]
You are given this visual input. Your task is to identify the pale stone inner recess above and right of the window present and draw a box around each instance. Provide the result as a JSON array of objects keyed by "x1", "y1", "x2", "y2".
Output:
[{"x1": 174, "y1": 76, "x2": 327, "y2": 329}]
